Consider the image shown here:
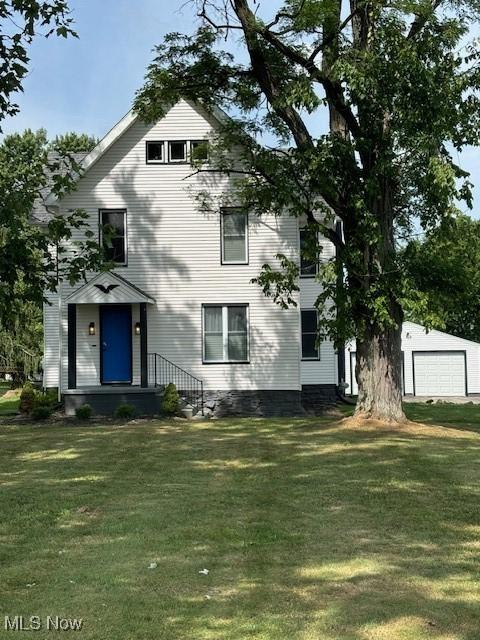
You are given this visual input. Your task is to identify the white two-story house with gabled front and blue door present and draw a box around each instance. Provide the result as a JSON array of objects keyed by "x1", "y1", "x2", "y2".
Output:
[{"x1": 44, "y1": 101, "x2": 338, "y2": 415}]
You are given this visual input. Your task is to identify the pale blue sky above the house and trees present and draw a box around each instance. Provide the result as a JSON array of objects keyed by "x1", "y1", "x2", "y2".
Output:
[{"x1": 2, "y1": 0, "x2": 480, "y2": 214}]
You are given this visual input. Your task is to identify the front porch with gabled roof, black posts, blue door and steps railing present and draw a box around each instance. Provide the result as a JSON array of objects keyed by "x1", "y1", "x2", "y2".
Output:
[{"x1": 62, "y1": 272, "x2": 203, "y2": 415}]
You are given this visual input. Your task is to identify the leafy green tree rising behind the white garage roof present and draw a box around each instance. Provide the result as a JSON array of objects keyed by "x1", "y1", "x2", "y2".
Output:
[{"x1": 405, "y1": 215, "x2": 480, "y2": 342}]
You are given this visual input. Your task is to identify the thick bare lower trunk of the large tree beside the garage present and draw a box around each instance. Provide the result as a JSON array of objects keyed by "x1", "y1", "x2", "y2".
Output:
[{"x1": 355, "y1": 312, "x2": 406, "y2": 423}]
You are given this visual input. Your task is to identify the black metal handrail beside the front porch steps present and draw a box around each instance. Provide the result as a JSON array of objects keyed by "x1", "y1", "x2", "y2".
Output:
[{"x1": 148, "y1": 353, "x2": 203, "y2": 416}]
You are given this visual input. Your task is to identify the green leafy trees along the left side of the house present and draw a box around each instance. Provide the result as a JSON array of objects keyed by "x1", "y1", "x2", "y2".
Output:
[{"x1": 0, "y1": 130, "x2": 104, "y2": 375}]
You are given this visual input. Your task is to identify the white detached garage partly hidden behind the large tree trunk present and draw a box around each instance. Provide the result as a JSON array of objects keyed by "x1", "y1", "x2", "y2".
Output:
[{"x1": 345, "y1": 322, "x2": 480, "y2": 397}]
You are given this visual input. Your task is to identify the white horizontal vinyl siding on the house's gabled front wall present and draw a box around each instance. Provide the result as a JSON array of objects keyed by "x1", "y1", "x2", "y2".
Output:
[{"x1": 51, "y1": 100, "x2": 300, "y2": 390}]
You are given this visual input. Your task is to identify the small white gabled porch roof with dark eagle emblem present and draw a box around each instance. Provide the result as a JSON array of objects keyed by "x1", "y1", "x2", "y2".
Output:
[{"x1": 65, "y1": 271, "x2": 155, "y2": 304}]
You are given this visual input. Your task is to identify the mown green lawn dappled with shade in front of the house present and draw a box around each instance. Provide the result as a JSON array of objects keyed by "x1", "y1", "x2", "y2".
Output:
[{"x1": 0, "y1": 405, "x2": 480, "y2": 640}]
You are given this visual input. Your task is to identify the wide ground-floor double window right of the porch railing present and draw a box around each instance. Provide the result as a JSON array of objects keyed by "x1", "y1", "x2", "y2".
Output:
[{"x1": 203, "y1": 304, "x2": 249, "y2": 363}]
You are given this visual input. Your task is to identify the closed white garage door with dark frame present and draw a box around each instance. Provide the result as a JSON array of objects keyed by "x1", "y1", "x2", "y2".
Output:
[{"x1": 412, "y1": 351, "x2": 465, "y2": 396}]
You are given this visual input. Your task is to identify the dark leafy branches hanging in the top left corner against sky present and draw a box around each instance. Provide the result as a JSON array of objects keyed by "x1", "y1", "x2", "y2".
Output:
[{"x1": 0, "y1": 0, "x2": 76, "y2": 129}]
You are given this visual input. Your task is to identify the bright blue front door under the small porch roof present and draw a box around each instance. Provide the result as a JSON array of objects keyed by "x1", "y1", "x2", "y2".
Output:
[{"x1": 100, "y1": 305, "x2": 132, "y2": 384}]
